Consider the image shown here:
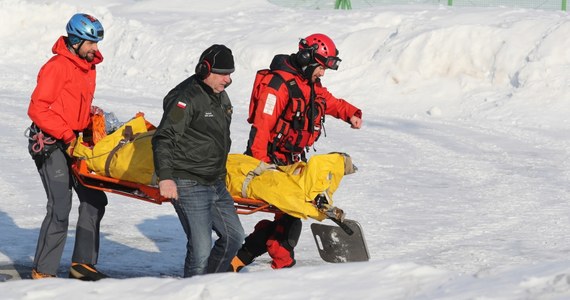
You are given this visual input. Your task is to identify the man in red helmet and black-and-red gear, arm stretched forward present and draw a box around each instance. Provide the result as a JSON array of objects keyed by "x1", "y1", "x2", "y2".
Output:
[{"x1": 232, "y1": 33, "x2": 362, "y2": 271}]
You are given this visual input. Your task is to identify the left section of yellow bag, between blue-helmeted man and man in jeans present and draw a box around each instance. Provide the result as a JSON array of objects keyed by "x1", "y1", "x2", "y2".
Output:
[{"x1": 73, "y1": 116, "x2": 156, "y2": 185}]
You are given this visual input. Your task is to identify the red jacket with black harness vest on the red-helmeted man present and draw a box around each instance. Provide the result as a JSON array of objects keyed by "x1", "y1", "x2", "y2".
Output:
[{"x1": 246, "y1": 55, "x2": 362, "y2": 164}]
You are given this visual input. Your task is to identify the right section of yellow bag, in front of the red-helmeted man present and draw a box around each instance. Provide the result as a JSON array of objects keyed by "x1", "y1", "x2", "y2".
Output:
[{"x1": 226, "y1": 153, "x2": 348, "y2": 221}]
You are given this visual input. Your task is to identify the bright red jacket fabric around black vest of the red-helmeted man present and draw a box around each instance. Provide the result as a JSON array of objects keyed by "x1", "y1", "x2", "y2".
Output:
[{"x1": 246, "y1": 55, "x2": 362, "y2": 162}]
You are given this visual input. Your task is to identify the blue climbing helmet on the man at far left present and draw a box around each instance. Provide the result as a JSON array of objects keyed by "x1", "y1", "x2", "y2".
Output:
[{"x1": 65, "y1": 13, "x2": 105, "y2": 45}]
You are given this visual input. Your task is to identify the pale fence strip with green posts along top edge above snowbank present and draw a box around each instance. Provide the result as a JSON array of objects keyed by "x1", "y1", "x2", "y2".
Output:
[{"x1": 269, "y1": 0, "x2": 568, "y2": 11}]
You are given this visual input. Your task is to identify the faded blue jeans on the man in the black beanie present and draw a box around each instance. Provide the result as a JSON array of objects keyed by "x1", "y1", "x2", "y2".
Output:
[{"x1": 172, "y1": 178, "x2": 245, "y2": 277}]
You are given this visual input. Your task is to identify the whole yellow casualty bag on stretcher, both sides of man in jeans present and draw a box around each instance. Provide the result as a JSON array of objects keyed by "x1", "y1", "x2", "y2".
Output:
[{"x1": 73, "y1": 116, "x2": 354, "y2": 221}]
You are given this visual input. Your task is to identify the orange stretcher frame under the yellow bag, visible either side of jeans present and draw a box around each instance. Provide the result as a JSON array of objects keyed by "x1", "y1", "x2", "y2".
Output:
[{"x1": 71, "y1": 159, "x2": 282, "y2": 215}]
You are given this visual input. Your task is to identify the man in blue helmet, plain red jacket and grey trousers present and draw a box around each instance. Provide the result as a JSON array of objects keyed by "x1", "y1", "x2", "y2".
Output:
[{"x1": 28, "y1": 14, "x2": 107, "y2": 281}]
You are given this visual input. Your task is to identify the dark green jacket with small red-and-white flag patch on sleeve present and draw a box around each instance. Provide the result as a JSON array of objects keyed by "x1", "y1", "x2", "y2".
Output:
[{"x1": 152, "y1": 76, "x2": 232, "y2": 184}]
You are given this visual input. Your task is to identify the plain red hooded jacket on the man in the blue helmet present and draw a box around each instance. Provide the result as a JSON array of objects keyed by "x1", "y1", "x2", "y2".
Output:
[{"x1": 28, "y1": 36, "x2": 103, "y2": 144}]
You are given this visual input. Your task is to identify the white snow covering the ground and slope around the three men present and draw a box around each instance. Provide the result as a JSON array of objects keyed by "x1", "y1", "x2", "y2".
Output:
[{"x1": 0, "y1": 0, "x2": 570, "y2": 300}]
